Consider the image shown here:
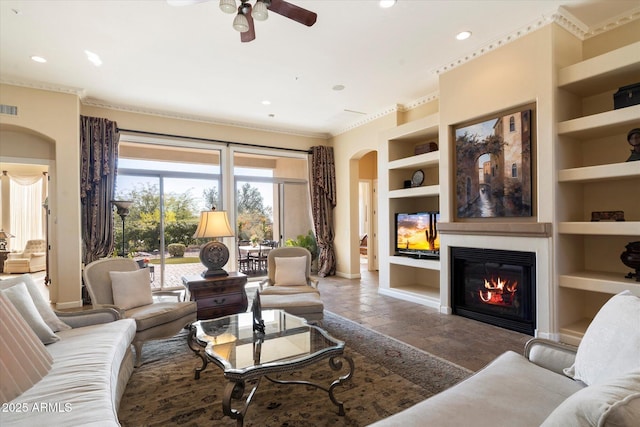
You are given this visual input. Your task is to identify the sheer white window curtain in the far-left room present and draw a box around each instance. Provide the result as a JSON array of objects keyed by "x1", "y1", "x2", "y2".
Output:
[{"x1": 9, "y1": 175, "x2": 46, "y2": 251}]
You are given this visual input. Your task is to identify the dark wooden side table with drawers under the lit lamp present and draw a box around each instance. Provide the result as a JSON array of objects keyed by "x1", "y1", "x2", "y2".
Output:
[{"x1": 182, "y1": 272, "x2": 249, "y2": 320}]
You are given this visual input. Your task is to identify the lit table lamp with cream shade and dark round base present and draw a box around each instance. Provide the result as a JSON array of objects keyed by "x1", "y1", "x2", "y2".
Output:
[{"x1": 193, "y1": 207, "x2": 238, "y2": 277}]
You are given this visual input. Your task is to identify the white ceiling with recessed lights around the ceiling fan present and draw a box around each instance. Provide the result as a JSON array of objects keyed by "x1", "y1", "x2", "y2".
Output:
[{"x1": 0, "y1": 0, "x2": 640, "y2": 137}]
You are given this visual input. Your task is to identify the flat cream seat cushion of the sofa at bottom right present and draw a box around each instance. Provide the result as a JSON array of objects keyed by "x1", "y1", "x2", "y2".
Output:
[{"x1": 364, "y1": 351, "x2": 584, "y2": 427}]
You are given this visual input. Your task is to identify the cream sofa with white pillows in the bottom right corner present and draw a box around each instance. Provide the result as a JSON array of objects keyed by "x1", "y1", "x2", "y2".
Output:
[{"x1": 372, "y1": 293, "x2": 640, "y2": 427}]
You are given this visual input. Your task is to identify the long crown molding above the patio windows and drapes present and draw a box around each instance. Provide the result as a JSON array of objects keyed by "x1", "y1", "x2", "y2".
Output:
[{"x1": 81, "y1": 97, "x2": 331, "y2": 139}]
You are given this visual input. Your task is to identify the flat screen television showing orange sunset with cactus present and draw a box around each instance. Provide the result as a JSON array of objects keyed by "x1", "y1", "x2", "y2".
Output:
[{"x1": 395, "y1": 212, "x2": 440, "y2": 258}]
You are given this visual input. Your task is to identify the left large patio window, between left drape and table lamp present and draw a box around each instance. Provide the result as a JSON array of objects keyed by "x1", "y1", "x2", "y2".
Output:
[{"x1": 114, "y1": 142, "x2": 222, "y2": 291}]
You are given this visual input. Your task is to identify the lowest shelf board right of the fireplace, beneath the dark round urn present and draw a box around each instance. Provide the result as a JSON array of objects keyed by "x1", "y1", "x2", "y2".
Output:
[{"x1": 559, "y1": 271, "x2": 640, "y2": 296}]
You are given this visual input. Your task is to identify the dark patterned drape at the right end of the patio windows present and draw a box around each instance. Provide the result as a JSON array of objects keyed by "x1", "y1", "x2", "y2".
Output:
[{"x1": 309, "y1": 146, "x2": 336, "y2": 277}]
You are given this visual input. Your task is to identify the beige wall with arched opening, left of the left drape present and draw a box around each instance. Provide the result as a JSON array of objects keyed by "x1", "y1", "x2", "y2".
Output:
[{"x1": 0, "y1": 85, "x2": 81, "y2": 308}]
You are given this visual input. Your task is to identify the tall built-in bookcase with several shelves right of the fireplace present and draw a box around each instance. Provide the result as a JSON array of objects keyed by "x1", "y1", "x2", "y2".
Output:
[{"x1": 554, "y1": 42, "x2": 640, "y2": 345}]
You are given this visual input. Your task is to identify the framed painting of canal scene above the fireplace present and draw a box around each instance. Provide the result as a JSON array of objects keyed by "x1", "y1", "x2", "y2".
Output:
[{"x1": 455, "y1": 110, "x2": 532, "y2": 218}]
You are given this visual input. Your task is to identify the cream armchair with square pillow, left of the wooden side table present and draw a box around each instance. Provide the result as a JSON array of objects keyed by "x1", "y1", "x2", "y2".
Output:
[{"x1": 82, "y1": 258, "x2": 196, "y2": 367}]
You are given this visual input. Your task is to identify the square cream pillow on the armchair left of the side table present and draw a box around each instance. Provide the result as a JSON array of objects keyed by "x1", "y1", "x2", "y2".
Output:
[{"x1": 109, "y1": 268, "x2": 153, "y2": 310}]
